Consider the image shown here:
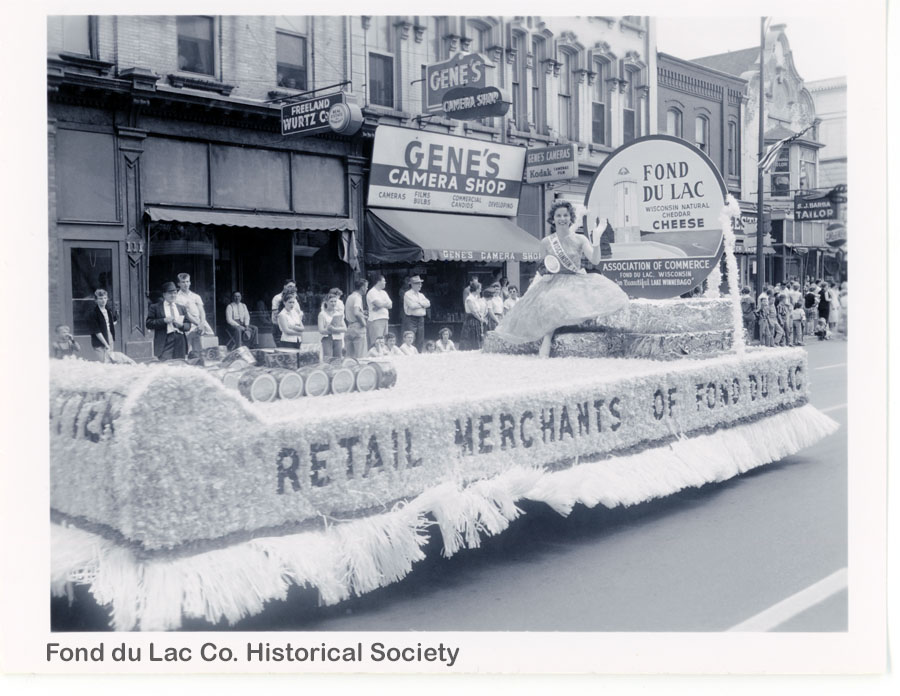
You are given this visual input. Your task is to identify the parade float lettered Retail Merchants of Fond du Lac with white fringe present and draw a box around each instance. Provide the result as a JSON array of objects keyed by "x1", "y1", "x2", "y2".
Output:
[{"x1": 50, "y1": 137, "x2": 837, "y2": 630}]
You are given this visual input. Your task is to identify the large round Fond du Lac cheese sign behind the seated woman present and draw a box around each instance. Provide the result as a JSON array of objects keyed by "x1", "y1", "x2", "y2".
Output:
[{"x1": 585, "y1": 135, "x2": 726, "y2": 299}]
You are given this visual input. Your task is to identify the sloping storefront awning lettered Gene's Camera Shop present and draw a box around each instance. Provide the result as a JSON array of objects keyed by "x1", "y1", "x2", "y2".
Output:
[{"x1": 366, "y1": 208, "x2": 541, "y2": 263}]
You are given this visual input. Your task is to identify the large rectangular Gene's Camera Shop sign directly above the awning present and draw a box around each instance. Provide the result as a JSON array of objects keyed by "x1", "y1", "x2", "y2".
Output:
[{"x1": 368, "y1": 126, "x2": 525, "y2": 217}]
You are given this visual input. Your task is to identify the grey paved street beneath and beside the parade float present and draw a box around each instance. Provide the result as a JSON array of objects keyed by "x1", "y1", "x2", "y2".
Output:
[{"x1": 256, "y1": 340, "x2": 847, "y2": 631}]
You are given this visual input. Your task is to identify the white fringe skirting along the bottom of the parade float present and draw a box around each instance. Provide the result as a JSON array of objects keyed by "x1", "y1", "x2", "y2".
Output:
[{"x1": 51, "y1": 405, "x2": 838, "y2": 631}]
